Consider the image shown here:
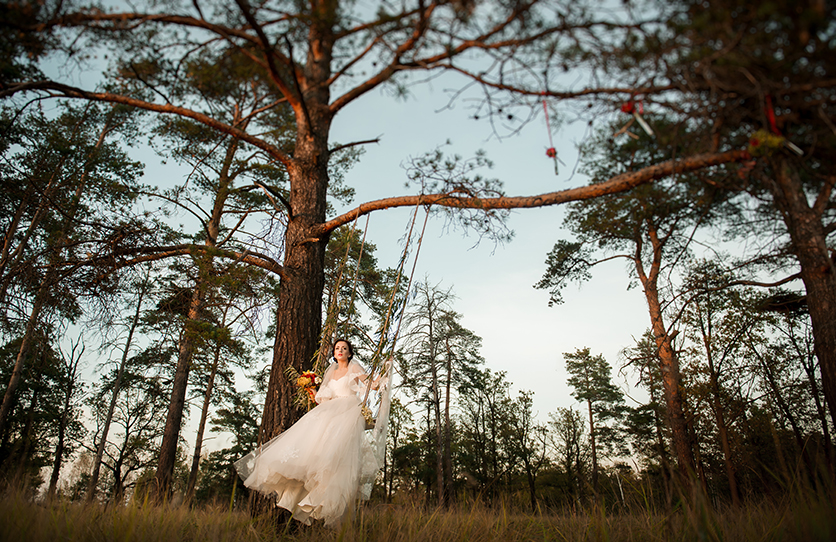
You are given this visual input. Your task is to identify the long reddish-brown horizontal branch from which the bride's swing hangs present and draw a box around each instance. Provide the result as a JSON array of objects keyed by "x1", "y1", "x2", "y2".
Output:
[{"x1": 310, "y1": 150, "x2": 751, "y2": 238}]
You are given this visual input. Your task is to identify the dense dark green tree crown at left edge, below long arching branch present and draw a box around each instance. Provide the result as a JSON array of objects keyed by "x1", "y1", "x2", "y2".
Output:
[{"x1": 0, "y1": 104, "x2": 147, "y2": 332}]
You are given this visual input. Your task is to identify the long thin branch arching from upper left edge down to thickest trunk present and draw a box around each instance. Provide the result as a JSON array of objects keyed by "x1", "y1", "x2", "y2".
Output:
[{"x1": 0, "y1": 81, "x2": 291, "y2": 166}]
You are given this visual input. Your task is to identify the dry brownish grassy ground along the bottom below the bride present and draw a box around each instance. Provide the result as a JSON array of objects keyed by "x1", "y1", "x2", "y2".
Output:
[{"x1": 0, "y1": 492, "x2": 836, "y2": 542}]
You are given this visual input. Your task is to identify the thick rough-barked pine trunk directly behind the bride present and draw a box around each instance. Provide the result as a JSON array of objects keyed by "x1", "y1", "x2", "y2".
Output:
[{"x1": 251, "y1": 55, "x2": 334, "y2": 513}]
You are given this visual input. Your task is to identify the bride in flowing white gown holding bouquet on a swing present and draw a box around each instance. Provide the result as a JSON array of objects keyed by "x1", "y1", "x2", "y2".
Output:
[{"x1": 235, "y1": 339, "x2": 388, "y2": 525}]
